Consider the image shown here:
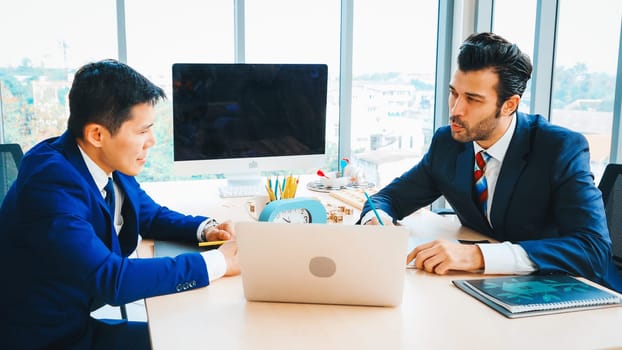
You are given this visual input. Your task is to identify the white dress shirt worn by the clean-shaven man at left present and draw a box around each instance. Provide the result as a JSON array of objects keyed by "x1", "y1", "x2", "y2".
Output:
[{"x1": 78, "y1": 146, "x2": 227, "y2": 281}]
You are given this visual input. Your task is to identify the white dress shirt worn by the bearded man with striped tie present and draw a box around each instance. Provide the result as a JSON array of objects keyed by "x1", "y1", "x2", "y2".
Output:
[{"x1": 361, "y1": 114, "x2": 537, "y2": 274}]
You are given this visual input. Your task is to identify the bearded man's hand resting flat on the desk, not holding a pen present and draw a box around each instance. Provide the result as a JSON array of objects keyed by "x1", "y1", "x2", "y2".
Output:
[{"x1": 406, "y1": 239, "x2": 484, "y2": 275}]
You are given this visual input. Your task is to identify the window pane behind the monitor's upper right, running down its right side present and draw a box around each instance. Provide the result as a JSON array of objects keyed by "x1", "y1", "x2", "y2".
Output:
[{"x1": 245, "y1": 0, "x2": 341, "y2": 175}]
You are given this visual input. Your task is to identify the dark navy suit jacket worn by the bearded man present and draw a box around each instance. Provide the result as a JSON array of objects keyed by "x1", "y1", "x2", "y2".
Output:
[{"x1": 361, "y1": 113, "x2": 622, "y2": 291}]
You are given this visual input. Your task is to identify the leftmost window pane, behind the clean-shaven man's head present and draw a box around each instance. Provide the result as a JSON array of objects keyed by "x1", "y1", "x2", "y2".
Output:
[{"x1": 0, "y1": 0, "x2": 117, "y2": 151}]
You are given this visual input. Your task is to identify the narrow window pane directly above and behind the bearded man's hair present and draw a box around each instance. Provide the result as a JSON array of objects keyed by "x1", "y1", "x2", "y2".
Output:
[{"x1": 492, "y1": 0, "x2": 536, "y2": 113}]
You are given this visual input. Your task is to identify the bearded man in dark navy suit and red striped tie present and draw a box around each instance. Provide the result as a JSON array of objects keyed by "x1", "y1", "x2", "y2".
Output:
[{"x1": 361, "y1": 33, "x2": 622, "y2": 291}]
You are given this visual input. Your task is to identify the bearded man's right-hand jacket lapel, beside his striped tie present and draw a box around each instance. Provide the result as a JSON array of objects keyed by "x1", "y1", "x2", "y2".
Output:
[{"x1": 490, "y1": 112, "x2": 531, "y2": 232}]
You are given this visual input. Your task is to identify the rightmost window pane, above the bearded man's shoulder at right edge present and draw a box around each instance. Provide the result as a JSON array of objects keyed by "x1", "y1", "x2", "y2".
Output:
[{"x1": 551, "y1": 0, "x2": 622, "y2": 183}]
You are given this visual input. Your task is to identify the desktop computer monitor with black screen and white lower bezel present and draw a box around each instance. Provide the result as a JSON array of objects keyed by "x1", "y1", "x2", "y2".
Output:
[{"x1": 173, "y1": 63, "x2": 328, "y2": 182}]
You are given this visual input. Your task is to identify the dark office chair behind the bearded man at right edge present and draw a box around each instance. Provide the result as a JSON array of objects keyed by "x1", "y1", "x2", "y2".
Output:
[{"x1": 598, "y1": 164, "x2": 622, "y2": 271}]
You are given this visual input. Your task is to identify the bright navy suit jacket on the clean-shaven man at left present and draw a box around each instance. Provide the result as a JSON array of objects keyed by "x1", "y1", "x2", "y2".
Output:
[{"x1": 0, "y1": 133, "x2": 209, "y2": 349}]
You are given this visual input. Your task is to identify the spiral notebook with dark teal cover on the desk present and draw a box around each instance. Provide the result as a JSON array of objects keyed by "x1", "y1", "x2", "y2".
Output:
[{"x1": 452, "y1": 275, "x2": 622, "y2": 318}]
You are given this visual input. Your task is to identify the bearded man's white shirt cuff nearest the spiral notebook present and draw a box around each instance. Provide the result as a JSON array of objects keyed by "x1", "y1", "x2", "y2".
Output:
[{"x1": 477, "y1": 242, "x2": 537, "y2": 275}]
